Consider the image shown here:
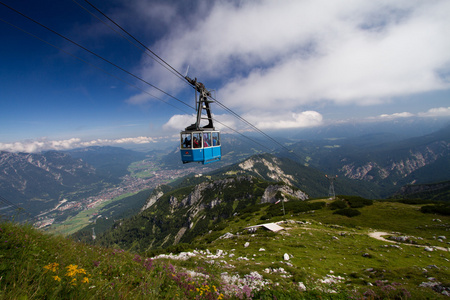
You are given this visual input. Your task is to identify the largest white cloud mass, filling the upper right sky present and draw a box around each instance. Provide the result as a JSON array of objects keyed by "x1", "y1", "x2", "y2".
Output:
[{"x1": 128, "y1": 0, "x2": 450, "y2": 117}]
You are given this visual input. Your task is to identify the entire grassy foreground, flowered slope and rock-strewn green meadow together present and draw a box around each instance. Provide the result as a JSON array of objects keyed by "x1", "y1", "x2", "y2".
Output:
[{"x1": 0, "y1": 198, "x2": 450, "y2": 299}]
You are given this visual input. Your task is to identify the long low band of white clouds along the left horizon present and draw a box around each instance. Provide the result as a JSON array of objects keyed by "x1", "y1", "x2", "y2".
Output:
[{"x1": 0, "y1": 136, "x2": 157, "y2": 153}]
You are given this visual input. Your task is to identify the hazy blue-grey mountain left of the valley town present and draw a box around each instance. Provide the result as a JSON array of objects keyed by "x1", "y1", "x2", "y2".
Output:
[{"x1": 0, "y1": 151, "x2": 104, "y2": 214}]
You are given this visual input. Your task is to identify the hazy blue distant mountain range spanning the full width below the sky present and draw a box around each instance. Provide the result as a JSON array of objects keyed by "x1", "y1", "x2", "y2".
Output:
[{"x1": 0, "y1": 125, "x2": 450, "y2": 223}]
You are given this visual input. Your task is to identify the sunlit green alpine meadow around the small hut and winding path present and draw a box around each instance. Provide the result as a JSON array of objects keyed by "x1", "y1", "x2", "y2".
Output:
[{"x1": 188, "y1": 200, "x2": 450, "y2": 299}]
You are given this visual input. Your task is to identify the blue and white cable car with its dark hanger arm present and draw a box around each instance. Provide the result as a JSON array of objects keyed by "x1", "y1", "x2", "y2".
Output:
[{"x1": 180, "y1": 76, "x2": 222, "y2": 164}]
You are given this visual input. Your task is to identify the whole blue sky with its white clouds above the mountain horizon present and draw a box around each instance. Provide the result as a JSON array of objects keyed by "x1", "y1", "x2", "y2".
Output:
[{"x1": 0, "y1": 0, "x2": 450, "y2": 152}]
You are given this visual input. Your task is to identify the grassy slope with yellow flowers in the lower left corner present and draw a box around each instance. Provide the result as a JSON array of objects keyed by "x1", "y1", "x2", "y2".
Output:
[{"x1": 0, "y1": 222, "x2": 223, "y2": 299}]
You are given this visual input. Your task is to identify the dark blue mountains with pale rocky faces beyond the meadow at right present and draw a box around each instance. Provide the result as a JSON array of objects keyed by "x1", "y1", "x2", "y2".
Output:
[{"x1": 284, "y1": 126, "x2": 450, "y2": 198}]
